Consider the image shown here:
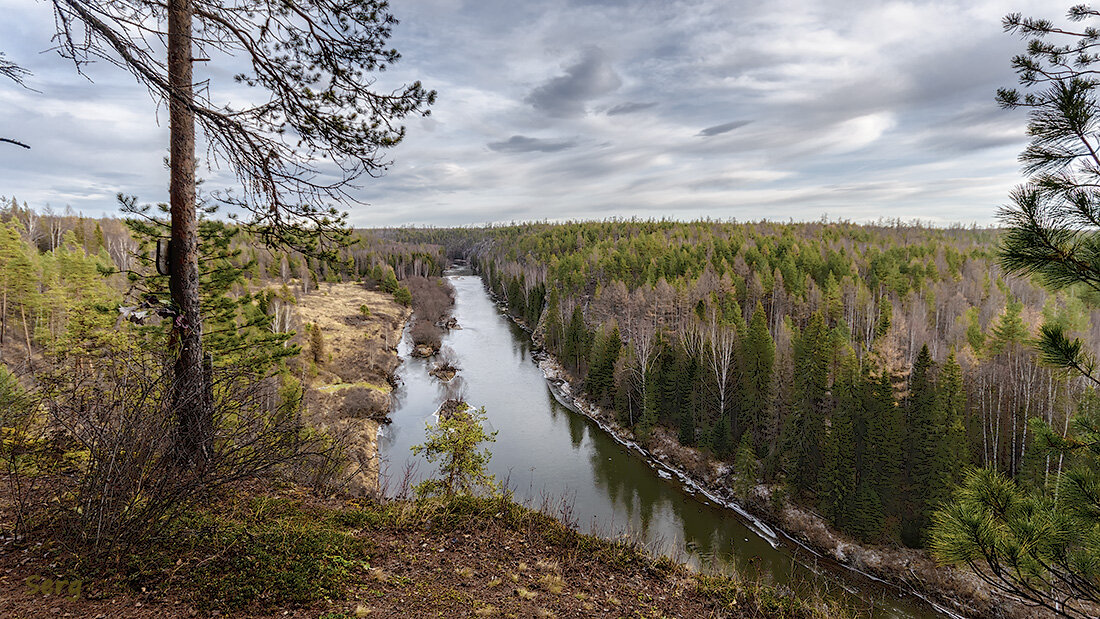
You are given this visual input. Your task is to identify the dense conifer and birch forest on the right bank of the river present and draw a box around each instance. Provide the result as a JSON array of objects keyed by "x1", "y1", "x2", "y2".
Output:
[{"x1": 395, "y1": 220, "x2": 1100, "y2": 548}]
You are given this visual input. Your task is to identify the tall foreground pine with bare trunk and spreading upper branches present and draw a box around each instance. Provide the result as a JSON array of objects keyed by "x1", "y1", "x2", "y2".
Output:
[{"x1": 53, "y1": 0, "x2": 436, "y2": 465}]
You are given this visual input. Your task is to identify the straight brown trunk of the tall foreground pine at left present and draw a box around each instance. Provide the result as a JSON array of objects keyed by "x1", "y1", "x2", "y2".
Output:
[{"x1": 168, "y1": 0, "x2": 212, "y2": 466}]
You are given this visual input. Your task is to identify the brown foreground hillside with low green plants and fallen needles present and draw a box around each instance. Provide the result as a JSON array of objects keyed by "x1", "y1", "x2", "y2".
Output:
[{"x1": 0, "y1": 486, "x2": 847, "y2": 619}]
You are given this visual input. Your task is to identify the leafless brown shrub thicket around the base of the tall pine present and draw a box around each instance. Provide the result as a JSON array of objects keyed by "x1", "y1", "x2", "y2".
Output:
[{"x1": 3, "y1": 350, "x2": 333, "y2": 555}]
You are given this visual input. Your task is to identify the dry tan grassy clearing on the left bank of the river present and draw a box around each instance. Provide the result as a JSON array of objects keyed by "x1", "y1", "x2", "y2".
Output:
[{"x1": 297, "y1": 283, "x2": 409, "y2": 496}]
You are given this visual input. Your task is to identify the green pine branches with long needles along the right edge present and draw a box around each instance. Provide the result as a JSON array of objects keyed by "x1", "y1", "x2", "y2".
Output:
[{"x1": 932, "y1": 5, "x2": 1100, "y2": 617}]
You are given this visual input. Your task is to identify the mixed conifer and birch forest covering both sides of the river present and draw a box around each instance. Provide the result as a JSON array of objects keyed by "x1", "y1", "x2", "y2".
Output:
[{"x1": 0, "y1": 194, "x2": 1082, "y2": 548}]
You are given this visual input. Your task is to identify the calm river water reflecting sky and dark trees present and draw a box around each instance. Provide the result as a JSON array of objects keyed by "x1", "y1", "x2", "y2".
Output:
[{"x1": 378, "y1": 275, "x2": 941, "y2": 618}]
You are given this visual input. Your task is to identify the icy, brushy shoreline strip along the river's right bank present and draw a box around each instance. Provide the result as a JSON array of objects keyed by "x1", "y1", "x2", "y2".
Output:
[{"x1": 479, "y1": 279, "x2": 1037, "y2": 619}]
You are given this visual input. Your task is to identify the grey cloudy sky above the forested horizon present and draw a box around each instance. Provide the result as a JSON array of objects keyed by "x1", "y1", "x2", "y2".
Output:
[{"x1": 0, "y1": 0, "x2": 1069, "y2": 226}]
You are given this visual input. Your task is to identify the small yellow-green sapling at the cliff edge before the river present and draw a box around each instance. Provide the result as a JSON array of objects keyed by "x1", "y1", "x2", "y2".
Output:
[{"x1": 413, "y1": 402, "x2": 499, "y2": 497}]
